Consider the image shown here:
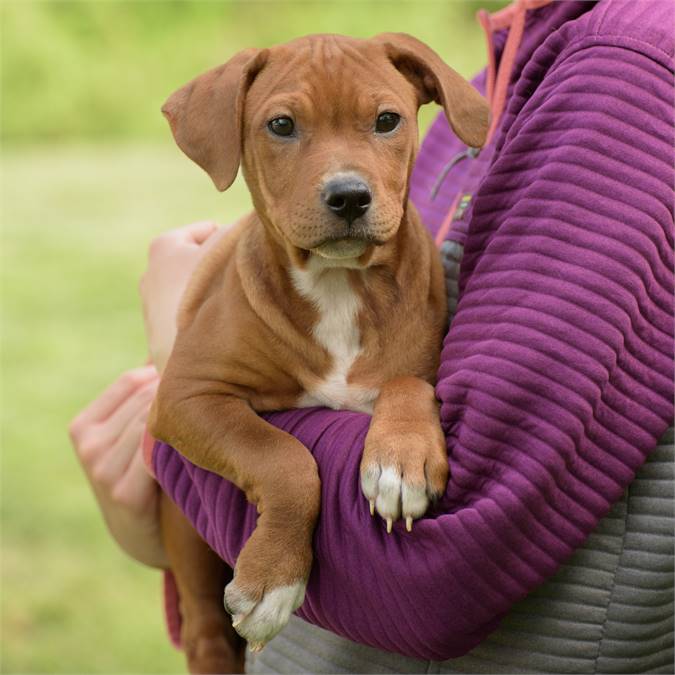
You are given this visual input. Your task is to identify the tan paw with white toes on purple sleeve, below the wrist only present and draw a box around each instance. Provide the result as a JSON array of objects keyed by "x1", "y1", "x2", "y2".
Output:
[{"x1": 361, "y1": 422, "x2": 448, "y2": 532}]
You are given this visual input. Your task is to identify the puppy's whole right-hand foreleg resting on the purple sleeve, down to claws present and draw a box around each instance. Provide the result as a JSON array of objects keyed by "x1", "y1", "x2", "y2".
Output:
[{"x1": 361, "y1": 377, "x2": 448, "y2": 532}]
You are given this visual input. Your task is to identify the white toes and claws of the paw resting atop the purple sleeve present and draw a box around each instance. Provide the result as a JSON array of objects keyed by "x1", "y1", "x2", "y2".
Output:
[{"x1": 361, "y1": 464, "x2": 429, "y2": 532}]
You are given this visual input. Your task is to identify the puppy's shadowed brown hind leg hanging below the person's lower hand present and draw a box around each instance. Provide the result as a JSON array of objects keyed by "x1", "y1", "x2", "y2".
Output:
[{"x1": 160, "y1": 494, "x2": 246, "y2": 673}]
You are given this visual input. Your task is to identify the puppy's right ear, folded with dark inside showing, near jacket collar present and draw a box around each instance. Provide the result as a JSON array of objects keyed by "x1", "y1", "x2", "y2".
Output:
[{"x1": 373, "y1": 33, "x2": 490, "y2": 148}]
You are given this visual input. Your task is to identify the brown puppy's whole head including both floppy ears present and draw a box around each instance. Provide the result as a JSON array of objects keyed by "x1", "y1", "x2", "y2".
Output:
[{"x1": 162, "y1": 33, "x2": 489, "y2": 261}]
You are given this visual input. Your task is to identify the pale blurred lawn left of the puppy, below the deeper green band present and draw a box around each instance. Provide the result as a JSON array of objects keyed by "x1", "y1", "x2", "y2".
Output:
[{"x1": 2, "y1": 144, "x2": 254, "y2": 673}]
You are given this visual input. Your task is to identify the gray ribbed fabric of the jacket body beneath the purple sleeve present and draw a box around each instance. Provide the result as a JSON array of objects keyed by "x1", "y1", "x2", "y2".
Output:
[{"x1": 246, "y1": 241, "x2": 675, "y2": 673}]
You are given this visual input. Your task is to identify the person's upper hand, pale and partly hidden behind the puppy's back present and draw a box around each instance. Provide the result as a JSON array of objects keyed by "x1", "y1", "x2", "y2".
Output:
[{"x1": 139, "y1": 221, "x2": 229, "y2": 372}]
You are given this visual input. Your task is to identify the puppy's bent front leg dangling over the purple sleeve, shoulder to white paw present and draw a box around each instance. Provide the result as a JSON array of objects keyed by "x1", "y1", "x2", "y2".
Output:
[{"x1": 149, "y1": 394, "x2": 321, "y2": 649}]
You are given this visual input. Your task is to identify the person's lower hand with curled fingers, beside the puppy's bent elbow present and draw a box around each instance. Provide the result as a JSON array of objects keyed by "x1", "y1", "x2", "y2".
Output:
[{"x1": 69, "y1": 366, "x2": 168, "y2": 567}]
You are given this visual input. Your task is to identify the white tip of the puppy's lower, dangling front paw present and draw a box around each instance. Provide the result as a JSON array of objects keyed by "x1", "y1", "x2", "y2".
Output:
[{"x1": 225, "y1": 579, "x2": 307, "y2": 651}]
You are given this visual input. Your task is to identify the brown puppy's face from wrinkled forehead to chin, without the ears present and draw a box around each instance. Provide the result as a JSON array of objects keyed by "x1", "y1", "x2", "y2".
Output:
[{"x1": 242, "y1": 36, "x2": 418, "y2": 255}]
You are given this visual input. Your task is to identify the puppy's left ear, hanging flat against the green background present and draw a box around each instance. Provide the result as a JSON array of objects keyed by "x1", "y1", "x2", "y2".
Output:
[{"x1": 162, "y1": 49, "x2": 268, "y2": 191}]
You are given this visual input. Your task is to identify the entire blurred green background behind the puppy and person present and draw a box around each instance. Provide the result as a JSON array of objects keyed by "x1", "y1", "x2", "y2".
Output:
[{"x1": 0, "y1": 0, "x2": 505, "y2": 673}]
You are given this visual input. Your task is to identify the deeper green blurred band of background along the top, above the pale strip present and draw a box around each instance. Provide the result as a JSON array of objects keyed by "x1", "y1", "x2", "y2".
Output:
[{"x1": 0, "y1": 0, "x2": 504, "y2": 141}]
